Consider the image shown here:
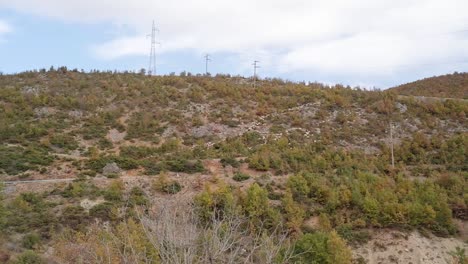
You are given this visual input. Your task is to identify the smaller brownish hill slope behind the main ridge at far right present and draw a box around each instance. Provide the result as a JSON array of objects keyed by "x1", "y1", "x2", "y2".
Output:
[{"x1": 391, "y1": 73, "x2": 468, "y2": 99}]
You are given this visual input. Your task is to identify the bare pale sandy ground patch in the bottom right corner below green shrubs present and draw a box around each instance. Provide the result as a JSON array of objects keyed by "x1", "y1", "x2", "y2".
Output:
[{"x1": 353, "y1": 230, "x2": 468, "y2": 264}]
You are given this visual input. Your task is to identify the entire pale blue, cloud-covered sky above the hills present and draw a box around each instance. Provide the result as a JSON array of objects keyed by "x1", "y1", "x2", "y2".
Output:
[{"x1": 0, "y1": 0, "x2": 468, "y2": 88}]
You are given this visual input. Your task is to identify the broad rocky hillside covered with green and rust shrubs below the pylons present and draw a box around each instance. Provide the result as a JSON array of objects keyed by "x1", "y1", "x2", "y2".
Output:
[{"x1": 0, "y1": 67, "x2": 468, "y2": 263}]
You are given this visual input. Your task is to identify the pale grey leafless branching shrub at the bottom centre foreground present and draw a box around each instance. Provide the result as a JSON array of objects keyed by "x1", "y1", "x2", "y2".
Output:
[{"x1": 136, "y1": 195, "x2": 293, "y2": 264}]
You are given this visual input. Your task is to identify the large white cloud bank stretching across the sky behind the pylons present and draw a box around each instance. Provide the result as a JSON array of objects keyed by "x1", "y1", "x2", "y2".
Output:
[{"x1": 0, "y1": 0, "x2": 468, "y2": 81}]
